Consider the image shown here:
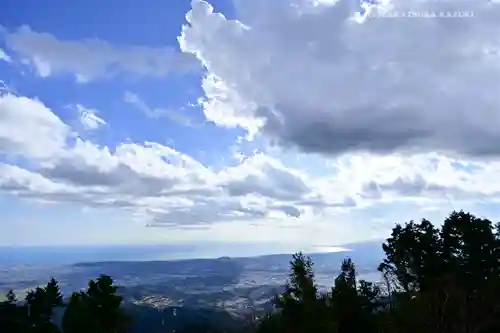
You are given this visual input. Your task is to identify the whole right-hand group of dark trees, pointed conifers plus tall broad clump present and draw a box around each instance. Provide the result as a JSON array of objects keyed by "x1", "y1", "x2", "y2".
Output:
[{"x1": 259, "y1": 211, "x2": 500, "y2": 333}]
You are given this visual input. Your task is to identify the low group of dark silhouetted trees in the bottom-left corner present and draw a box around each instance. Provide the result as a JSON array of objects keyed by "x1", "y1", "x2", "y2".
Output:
[{"x1": 0, "y1": 275, "x2": 128, "y2": 333}]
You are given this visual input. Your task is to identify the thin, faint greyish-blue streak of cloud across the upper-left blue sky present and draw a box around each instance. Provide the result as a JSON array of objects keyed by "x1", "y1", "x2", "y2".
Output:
[{"x1": 3, "y1": 26, "x2": 201, "y2": 82}]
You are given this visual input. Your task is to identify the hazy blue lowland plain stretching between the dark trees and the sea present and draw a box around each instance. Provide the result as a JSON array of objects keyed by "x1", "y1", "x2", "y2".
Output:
[{"x1": 0, "y1": 242, "x2": 383, "y2": 322}]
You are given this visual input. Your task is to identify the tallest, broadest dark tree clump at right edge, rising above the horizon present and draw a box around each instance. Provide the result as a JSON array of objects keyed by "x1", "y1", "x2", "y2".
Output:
[{"x1": 379, "y1": 211, "x2": 500, "y2": 332}]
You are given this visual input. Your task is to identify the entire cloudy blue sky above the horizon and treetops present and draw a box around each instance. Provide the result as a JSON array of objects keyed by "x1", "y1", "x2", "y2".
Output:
[{"x1": 0, "y1": 0, "x2": 500, "y2": 247}]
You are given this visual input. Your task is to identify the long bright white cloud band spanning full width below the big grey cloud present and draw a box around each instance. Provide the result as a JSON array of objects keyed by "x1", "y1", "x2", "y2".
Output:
[{"x1": 0, "y1": 94, "x2": 500, "y2": 243}]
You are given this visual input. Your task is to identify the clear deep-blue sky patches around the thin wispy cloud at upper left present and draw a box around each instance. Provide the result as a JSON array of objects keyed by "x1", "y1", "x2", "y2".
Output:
[{"x1": 0, "y1": 0, "x2": 241, "y2": 161}]
